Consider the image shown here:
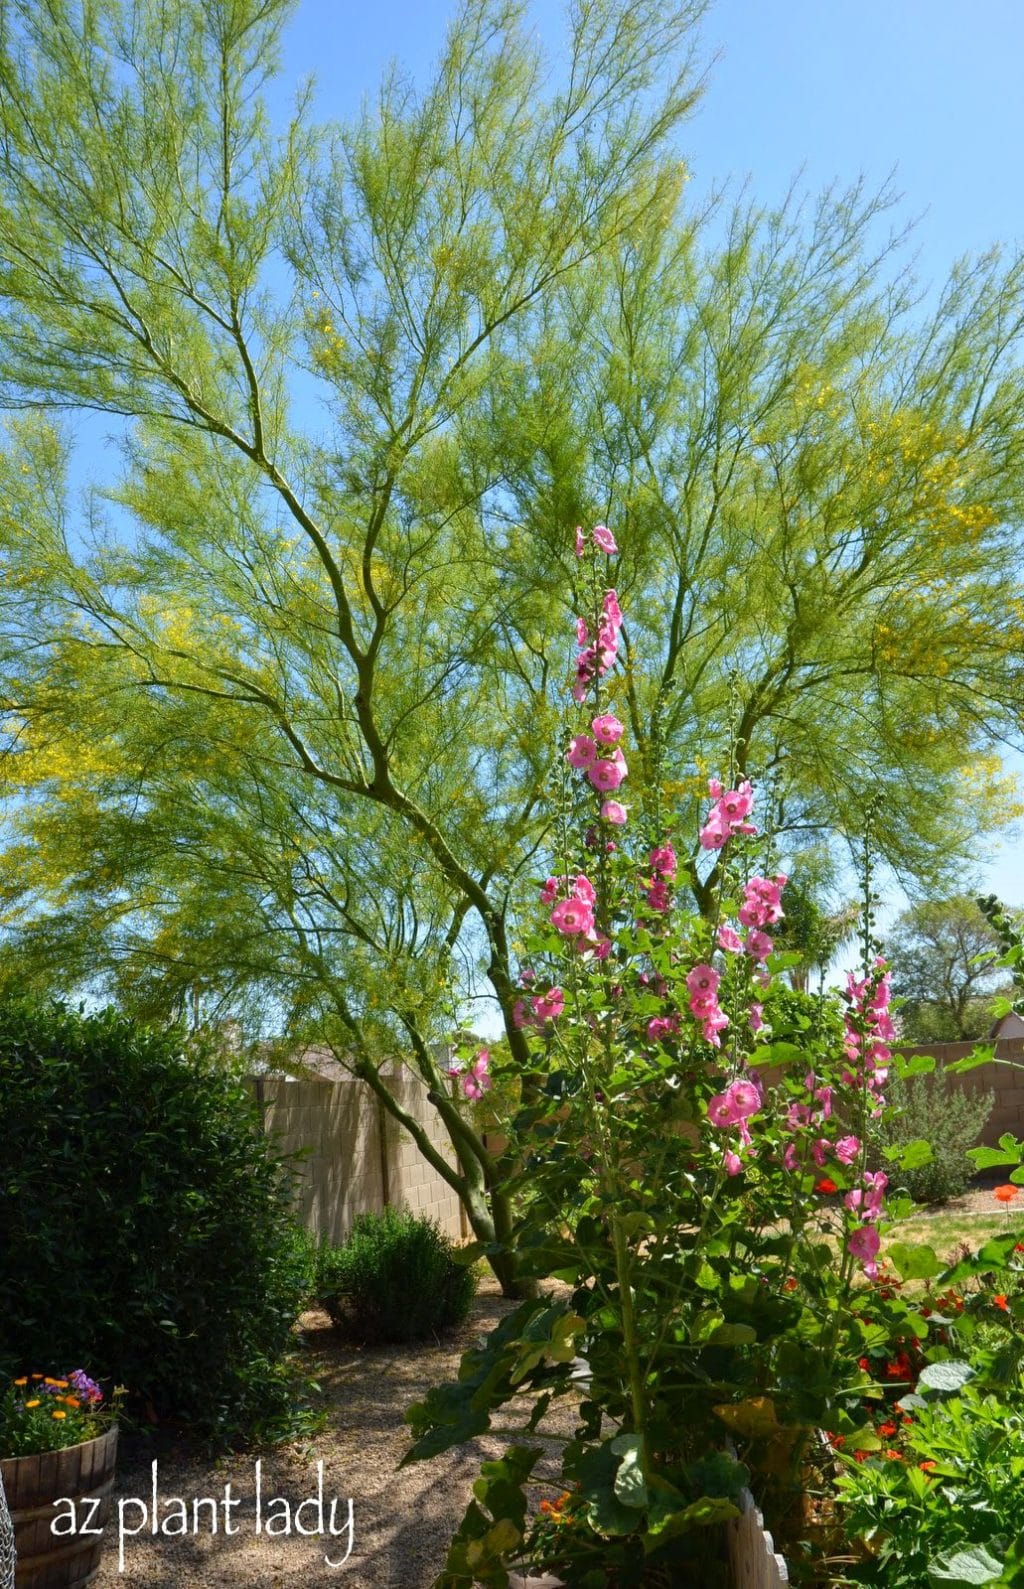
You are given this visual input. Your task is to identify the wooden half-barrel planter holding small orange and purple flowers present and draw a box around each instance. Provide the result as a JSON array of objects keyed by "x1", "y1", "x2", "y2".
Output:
[{"x1": 0, "y1": 1424, "x2": 118, "y2": 1589}]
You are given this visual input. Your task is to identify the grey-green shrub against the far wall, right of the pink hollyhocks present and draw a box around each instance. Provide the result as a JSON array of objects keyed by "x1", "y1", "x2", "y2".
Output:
[{"x1": 870, "y1": 1069, "x2": 995, "y2": 1203}]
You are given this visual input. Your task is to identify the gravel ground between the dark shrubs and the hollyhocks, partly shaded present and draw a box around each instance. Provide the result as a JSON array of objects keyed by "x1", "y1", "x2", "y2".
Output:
[{"x1": 94, "y1": 1281, "x2": 546, "y2": 1589}]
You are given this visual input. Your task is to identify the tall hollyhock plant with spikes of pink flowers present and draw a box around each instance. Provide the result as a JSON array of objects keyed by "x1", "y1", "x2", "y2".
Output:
[{"x1": 410, "y1": 526, "x2": 954, "y2": 1589}]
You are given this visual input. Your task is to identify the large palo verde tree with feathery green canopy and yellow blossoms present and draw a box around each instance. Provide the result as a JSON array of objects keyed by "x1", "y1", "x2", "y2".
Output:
[{"x1": 0, "y1": 0, "x2": 1024, "y2": 1282}]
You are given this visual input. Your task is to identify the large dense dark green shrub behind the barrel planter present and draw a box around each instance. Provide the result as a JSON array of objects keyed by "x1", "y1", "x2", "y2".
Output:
[{"x1": 0, "y1": 1003, "x2": 308, "y2": 1440}]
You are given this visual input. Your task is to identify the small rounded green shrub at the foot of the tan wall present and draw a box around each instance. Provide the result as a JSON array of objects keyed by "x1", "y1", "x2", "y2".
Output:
[{"x1": 318, "y1": 1208, "x2": 475, "y2": 1341}]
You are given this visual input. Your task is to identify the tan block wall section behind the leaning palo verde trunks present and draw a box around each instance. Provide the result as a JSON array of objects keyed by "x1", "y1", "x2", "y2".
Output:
[{"x1": 251, "y1": 1068, "x2": 467, "y2": 1243}]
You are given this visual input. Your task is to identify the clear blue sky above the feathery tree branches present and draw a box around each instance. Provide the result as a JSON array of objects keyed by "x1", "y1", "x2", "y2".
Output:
[{"x1": 265, "y1": 0, "x2": 1024, "y2": 904}]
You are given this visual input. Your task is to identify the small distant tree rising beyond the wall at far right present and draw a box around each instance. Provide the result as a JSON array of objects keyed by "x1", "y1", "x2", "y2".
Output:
[{"x1": 884, "y1": 895, "x2": 1008, "y2": 1042}]
